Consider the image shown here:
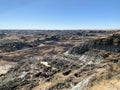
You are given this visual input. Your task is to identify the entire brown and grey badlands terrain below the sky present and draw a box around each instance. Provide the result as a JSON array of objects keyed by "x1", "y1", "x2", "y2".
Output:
[{"x1": 0, "y1": 30, "x2": 120, "y2": 90}]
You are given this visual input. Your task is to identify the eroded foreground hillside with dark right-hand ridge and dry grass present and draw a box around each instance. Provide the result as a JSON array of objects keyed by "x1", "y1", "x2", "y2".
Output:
[{"x1": 0, "y1": 34, "x2": 120, "y2": 90}]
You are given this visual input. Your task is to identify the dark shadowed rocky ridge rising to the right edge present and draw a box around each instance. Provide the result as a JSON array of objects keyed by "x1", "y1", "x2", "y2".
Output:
[{"x1": 69, "y1": 34, "x2": 120, "y2": 54}]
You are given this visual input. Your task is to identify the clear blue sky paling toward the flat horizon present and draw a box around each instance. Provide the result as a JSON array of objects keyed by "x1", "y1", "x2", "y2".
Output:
[{"x1": 0, "y1": 0, "x2": 120, "y2": 29}]
